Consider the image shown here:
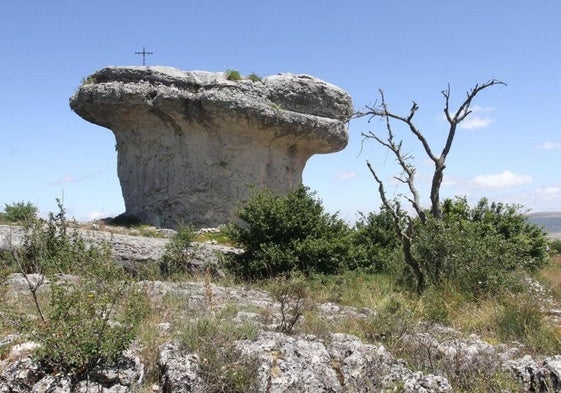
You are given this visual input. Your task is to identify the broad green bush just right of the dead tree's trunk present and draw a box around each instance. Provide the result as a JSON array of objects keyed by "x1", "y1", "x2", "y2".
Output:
[{"x1": 412, "y1": 198, "x2": 547, "y2": 294}]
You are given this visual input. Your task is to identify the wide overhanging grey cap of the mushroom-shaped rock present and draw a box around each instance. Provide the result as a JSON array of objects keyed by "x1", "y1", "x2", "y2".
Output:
[{"x1": 70, "y1": 66, "x2": 353, "y2": 153}]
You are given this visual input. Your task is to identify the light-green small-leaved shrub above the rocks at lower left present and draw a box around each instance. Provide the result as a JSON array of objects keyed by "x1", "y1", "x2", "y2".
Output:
[{"x1": 31, "y1": 276, "x2": 146, "y2": 374}]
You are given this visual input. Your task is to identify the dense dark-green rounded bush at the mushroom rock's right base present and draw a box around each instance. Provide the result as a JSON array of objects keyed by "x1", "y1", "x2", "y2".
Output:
[{"x1": 226, "y1": 187, "x2": 358, "y2": 279}]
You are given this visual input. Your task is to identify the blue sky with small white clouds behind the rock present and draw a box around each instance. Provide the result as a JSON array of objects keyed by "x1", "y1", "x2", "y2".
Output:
[{"x1": 0, "y1": 0, "x2": 561, "y2": 221}]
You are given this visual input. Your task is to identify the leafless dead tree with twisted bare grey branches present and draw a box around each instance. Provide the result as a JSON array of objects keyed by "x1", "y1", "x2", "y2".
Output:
[{"x1": 355, "y1": 79, "x2": 506, "y2": 291}]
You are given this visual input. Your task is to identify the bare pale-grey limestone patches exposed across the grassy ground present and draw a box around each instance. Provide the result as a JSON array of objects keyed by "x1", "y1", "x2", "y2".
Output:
[{"x1": 0, "y1": 226, "x2": 561, "y2": 393}]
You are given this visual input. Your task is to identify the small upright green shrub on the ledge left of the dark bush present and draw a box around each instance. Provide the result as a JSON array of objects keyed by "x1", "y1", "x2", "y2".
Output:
[{"x1": 160, "y1": 225, "x2": 196, "y2": 277}]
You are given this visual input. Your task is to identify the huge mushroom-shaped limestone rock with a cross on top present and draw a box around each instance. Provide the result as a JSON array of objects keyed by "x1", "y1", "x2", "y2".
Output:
[{"x1": 70, "y1": 67, "x2": 352, "y2": 228}]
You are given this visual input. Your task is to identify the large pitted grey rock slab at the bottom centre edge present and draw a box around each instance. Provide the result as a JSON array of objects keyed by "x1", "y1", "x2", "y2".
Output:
[{"x1": 233, "y1": 332, "x2": 452, "y2": 393}]
